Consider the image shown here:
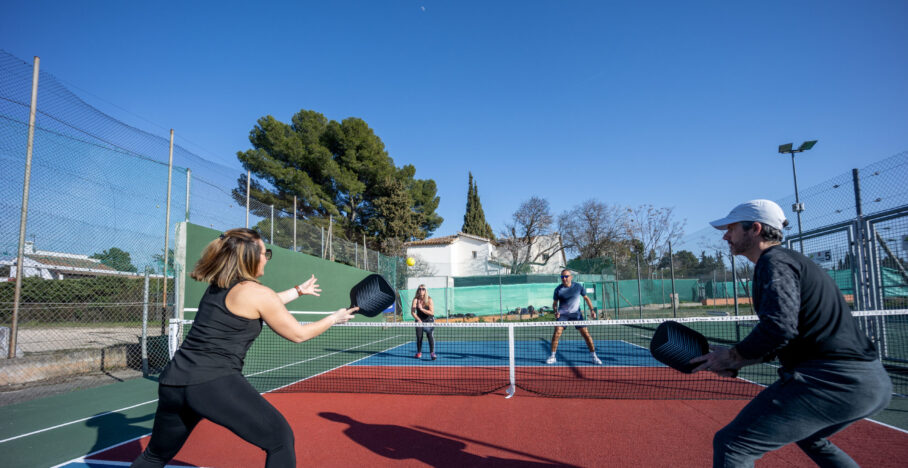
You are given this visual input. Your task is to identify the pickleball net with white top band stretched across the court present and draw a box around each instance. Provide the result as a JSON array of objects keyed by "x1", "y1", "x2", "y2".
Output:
[{"x1": 171, "y1": 310, "x2": 908, "y2": 399}]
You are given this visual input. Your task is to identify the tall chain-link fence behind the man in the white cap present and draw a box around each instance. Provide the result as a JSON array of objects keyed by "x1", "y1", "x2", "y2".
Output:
[{"x1": 675, "y1": 152, "x2": 908, "y2": 311}]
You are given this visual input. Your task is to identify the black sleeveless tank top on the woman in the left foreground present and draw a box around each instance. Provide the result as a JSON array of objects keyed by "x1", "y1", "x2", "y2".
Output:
[{"x1": 158, "y1": 283, "x2": 262, "y2": 385}]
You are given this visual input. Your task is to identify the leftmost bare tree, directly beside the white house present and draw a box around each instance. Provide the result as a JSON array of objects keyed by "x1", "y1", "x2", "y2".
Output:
[{"x1": 498, "y1": 197, "x2": 564, "y2": 273}]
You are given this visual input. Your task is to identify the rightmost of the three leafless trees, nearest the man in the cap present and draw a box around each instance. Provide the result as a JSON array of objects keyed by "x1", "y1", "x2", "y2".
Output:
[{"x1": 625, "y1": 205, "x2": 685, "y2": 274}]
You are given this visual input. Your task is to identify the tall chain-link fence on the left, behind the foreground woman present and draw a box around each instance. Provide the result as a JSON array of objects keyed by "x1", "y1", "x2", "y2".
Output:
[{"x1": 0, "y1": 51, "x2": 406, "y2": 405}]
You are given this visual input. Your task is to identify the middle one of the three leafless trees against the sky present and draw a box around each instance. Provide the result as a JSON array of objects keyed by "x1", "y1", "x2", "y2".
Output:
[{"x1": 558, "y1": 199, "x2": 627, "y2": 259}]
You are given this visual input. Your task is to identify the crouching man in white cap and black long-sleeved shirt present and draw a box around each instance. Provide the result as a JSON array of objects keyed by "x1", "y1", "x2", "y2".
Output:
[{"x1": 691, "y1": 200, "x2": 892, "y2": 467}]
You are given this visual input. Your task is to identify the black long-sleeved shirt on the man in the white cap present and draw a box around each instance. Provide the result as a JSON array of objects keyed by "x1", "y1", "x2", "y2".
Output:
[{"x1": 735, "y1": 246, "x2": 877, "y2": 368}]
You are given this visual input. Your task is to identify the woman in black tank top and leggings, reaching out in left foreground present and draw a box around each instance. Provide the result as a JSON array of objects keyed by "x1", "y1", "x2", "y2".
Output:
[{"x1": 132, "y1": 229, "x2": 356, "y2": 468}]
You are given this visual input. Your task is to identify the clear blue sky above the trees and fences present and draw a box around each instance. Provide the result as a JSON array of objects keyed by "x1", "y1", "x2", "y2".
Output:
[{"x1": 0, "y1": 0, "x2": 908, "y2": 241}]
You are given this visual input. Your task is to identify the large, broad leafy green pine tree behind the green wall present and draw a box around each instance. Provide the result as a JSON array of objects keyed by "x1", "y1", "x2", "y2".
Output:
[{"x1": 233, "y1": 110, "x2": 443, "y2": 250}]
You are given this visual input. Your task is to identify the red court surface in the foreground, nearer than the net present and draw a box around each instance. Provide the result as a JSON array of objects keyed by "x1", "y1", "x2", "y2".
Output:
[{"x1": 92, "y1": 393, "x2": 908, "y2": 467}]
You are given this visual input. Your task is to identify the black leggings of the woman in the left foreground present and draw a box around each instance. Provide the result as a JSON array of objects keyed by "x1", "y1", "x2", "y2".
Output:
[{"x1": 132, "y1": 374, "x2": 296, "y2": 468}]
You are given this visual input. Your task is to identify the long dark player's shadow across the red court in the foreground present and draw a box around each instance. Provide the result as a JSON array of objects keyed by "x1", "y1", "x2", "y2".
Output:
[{"x1": 319, "y1": 412, "x2": 576, "y2": 467}]
